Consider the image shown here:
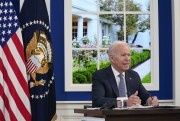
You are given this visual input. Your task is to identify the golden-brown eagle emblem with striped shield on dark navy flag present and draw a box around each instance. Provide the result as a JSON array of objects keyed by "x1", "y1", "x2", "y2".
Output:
[{"x1": 26, "y1": 31, "x2": 52, "y2": 88}]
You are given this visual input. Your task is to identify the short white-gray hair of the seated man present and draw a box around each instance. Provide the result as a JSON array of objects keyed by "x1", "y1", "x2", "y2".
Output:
[{"x1": 108, "y1": 41, "x2": 128, "y2": 55}]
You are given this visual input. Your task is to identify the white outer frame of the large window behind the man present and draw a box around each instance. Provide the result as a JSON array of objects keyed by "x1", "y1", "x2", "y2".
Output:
[{"x1": 64, "y1": 0, "x2": 159, "y2": 92}]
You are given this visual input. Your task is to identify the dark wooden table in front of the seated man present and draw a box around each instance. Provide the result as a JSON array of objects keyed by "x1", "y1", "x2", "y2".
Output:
[{"x1": 74, "y1": 106, "x2": 180, "y2": 121}]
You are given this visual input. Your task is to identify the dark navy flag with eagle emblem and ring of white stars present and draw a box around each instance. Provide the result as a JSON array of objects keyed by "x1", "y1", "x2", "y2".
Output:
[{"x1": 20, "y1": 0, "x2": 56, "y2": 121}]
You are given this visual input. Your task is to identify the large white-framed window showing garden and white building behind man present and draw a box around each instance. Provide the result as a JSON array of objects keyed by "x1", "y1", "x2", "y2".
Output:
[{"x1": 65, "y1": 0, "x2": 159, "y2": 91}]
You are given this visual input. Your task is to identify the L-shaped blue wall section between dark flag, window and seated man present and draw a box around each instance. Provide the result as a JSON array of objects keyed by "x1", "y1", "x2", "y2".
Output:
[{"x1": 51, "y1": 0, "x2": 91, "y2": 101}]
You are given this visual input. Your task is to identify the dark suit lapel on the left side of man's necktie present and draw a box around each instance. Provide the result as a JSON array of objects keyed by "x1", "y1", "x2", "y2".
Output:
[{"x1": 107, "y1": 66, "x2": 119, "y2": 97}]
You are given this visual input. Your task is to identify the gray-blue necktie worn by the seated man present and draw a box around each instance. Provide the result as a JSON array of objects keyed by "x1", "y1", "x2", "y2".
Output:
[{"x1": 119, "y1": 73, "x2": 126, "y2": 97}]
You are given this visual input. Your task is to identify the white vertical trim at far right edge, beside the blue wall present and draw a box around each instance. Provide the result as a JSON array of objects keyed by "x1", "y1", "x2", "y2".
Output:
[{"x1": 172, "y1": 0, "x2": 180, "y2": 106}]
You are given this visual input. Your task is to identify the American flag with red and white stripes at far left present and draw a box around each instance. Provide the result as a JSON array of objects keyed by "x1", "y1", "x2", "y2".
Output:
[{"x1": 0, "y1": 0, "x2": 31, "y2": 121}]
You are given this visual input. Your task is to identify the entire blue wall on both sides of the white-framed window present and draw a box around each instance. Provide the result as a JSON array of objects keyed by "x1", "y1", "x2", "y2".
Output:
[{"x1": 14, "y1": 0, "x2": 173, "y2": 101}]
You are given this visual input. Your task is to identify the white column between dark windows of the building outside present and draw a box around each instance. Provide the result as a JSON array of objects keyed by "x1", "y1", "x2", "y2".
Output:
[{"x1": 77, "y1": 17, "x2": 83, "y2": 40}]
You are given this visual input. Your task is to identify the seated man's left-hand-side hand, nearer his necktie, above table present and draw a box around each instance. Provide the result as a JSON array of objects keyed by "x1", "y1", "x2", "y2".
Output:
[{"x1": 127, "y1": 91, "x2": 141, "y2": 107}]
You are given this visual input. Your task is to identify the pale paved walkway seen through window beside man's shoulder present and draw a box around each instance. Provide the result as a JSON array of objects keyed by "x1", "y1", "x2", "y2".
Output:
[{"x1": 133, "y1": 59, "x2": 151, "y2": 79}]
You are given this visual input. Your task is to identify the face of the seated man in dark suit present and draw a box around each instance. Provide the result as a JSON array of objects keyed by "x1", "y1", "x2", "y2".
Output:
[{"x1": 111, "y1": 45, "x2": 131, "y2": 73}]
